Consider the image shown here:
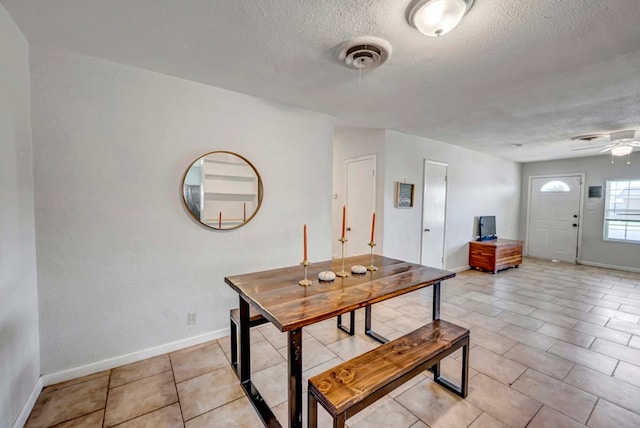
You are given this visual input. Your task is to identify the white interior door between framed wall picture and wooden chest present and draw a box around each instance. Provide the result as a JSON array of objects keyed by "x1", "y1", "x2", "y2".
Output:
[{"x1": 420, "y1": 160, "x2": 447, "y2": 268}]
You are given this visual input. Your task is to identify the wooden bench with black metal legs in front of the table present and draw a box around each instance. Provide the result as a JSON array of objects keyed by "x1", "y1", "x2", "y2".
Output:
[{"x1": 308, "y1": 320, "x2": 469, "y2": 428}]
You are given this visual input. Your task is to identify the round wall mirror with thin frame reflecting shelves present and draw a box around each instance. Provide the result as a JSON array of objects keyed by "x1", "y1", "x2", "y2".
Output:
[{"x1": 182, "y1": 151, "x2": 262, "y2": 230}]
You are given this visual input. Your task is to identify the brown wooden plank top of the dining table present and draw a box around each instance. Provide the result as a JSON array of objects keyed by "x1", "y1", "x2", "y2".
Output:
[{"x1": 224, "y1": 254, "x2": 456, "y2": 332}]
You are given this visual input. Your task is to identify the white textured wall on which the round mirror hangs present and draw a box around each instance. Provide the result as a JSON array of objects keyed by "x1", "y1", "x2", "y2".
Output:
[{"x1": 31, "y1": 44, "x2": 333, "y2": 373}]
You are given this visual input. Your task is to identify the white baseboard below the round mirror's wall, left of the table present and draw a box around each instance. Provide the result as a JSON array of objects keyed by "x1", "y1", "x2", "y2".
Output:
[{"x1": 41, "y1": 328, "x2": 229, "y2": 388}]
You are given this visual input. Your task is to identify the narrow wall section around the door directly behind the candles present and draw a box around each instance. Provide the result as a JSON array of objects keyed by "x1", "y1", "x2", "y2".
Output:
[{"x1": 331, "y1": 128, "x2": 385, "y2": 257}]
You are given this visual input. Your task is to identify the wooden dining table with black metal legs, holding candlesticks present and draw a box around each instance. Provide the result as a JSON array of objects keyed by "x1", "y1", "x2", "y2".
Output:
[{"x1": 225, "y1": 255, "x2": 455, "y2": 428}]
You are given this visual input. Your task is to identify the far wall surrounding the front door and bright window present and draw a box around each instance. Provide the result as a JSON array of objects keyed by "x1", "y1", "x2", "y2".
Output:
[{"x1": 520, "y1": 152, "x2": 640, "y2": 270}]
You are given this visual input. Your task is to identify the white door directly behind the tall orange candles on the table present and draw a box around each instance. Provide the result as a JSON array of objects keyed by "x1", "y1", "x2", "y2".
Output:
[{"x1": 345, "y1": 155, "x2": 376, "y2": 256}]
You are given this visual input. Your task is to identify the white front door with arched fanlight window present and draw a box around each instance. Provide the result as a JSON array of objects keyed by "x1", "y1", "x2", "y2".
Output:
[{"x1": 527, "y1": 175, "x2": 582, "y2": 263}]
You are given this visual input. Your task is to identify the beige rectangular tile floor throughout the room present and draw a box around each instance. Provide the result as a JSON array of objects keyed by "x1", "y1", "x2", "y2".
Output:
[{"x1": 22, "y1": 259, "x2": 640, "y2": 428}]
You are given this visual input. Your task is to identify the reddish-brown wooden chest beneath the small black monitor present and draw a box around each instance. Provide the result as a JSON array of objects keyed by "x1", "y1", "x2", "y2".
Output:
[{"x1": 469, "y1": 239, "x2": 522, "y2": 273}]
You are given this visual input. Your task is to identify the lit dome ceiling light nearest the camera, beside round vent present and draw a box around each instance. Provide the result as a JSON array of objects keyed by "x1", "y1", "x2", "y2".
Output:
[{"x1": 408, "y1": 0, "x2": 474, "y2": 37}]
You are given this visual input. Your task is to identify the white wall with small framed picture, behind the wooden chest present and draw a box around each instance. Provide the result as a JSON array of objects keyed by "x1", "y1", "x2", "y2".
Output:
[{"x1": 384, "y1": 130, "x2": 521, "y2": 270}]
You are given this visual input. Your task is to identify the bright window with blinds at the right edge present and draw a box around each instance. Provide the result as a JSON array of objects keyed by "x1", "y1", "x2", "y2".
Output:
[{"x1": 604, "y1": 180, "x2": 640, "y2": 243}]
